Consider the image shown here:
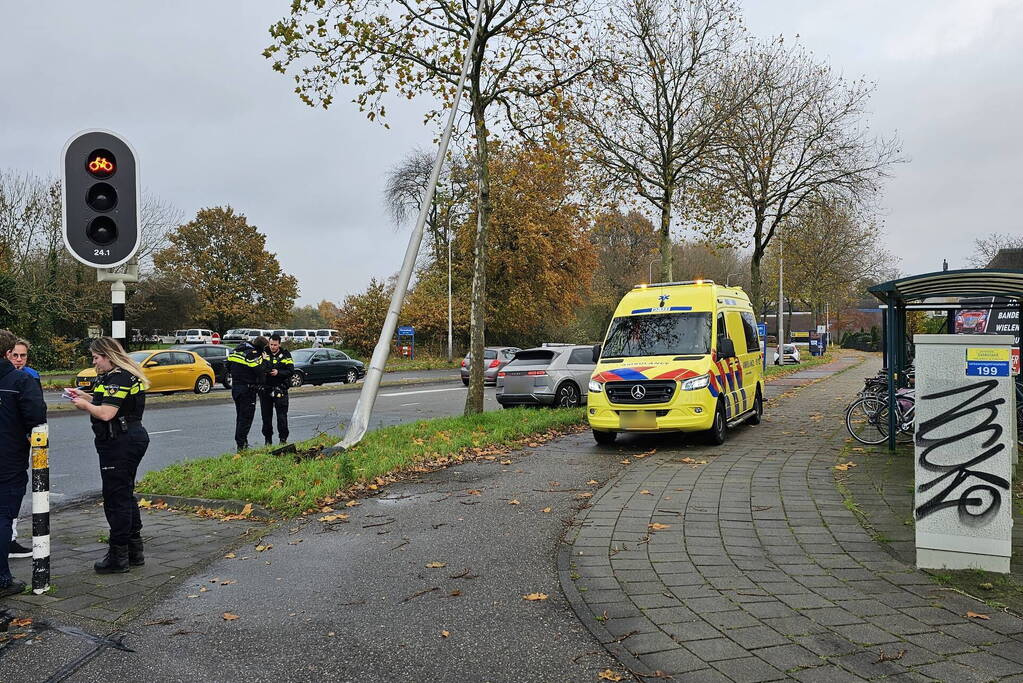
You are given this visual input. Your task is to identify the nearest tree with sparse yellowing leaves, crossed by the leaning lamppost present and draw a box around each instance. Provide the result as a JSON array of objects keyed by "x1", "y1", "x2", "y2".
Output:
[{"x1": 264, "y1": 0, "x2": 593, "y2": 414}]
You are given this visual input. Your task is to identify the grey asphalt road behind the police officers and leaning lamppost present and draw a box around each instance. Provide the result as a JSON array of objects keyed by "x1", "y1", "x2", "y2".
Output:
[{"x1": 29, "y1": 371, "x2": 499, "y2": 514}]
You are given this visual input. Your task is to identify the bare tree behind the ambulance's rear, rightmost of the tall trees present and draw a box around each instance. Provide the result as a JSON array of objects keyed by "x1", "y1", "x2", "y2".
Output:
[{"x1": 713, "y1": 39, "x2": 900, "y2": 311}]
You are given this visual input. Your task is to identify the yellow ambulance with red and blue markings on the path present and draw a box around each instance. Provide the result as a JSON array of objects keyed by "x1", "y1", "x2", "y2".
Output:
[{"x1": 586, "y1": 280, "x2": 764, "y2": 444}]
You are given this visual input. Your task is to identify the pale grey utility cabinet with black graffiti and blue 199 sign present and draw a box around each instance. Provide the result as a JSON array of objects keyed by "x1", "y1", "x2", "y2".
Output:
[{"x1": 914, "y1": 334, "x2": 1016, "y2": 573}]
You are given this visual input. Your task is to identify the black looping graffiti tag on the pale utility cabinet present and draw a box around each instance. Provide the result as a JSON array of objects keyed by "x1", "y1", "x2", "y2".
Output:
[{"x1": 917, "y1": 379, "x2": 1009, "y2": 527}]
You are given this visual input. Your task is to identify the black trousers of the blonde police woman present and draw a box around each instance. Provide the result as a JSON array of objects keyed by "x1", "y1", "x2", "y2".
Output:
[{"x1": 96, "y1": 422, "x2": 149, "y2": 545}]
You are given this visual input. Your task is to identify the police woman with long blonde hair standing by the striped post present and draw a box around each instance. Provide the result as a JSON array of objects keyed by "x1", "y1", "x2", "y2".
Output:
[{"x1": 71, "y1": 336, "x2": 149, "y2": 574}]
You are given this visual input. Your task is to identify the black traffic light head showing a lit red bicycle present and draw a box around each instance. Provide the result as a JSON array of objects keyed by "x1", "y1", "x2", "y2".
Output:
[{"x1": 61, "y1": 130, "x2": 139, "y2": 268}]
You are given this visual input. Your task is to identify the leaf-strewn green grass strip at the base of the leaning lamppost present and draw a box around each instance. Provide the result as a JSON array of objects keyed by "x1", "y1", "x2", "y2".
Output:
[{"x1": 136, "y1": 408, "x2": 585, "y2": 515}]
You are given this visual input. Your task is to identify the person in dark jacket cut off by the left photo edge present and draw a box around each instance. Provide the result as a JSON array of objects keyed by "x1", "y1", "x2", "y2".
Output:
[{"x1": 0, "y1": 329, "x2": 46, "y2": 597}]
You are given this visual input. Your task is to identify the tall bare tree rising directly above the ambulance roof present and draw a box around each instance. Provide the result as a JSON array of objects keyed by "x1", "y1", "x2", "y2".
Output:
[{"x1": 572, "y1": 0, "x2": 749, "y2": 281}]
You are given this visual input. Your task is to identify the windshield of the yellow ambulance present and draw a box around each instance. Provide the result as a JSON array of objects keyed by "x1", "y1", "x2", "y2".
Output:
[{"x1": 601, "y1": 313, "x2": 711, "y2": 358}]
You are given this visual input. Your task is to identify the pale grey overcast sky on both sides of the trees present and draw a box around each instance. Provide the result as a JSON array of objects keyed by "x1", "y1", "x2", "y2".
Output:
[{"x1": 0, "y1": 0, "x2": 1023, "y2": 304}]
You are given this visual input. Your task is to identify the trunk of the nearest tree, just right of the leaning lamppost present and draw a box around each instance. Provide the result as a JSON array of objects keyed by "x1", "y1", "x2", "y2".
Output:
[{"x1": 464, "y1": 86, "x2": 490, "y2": 415}]
